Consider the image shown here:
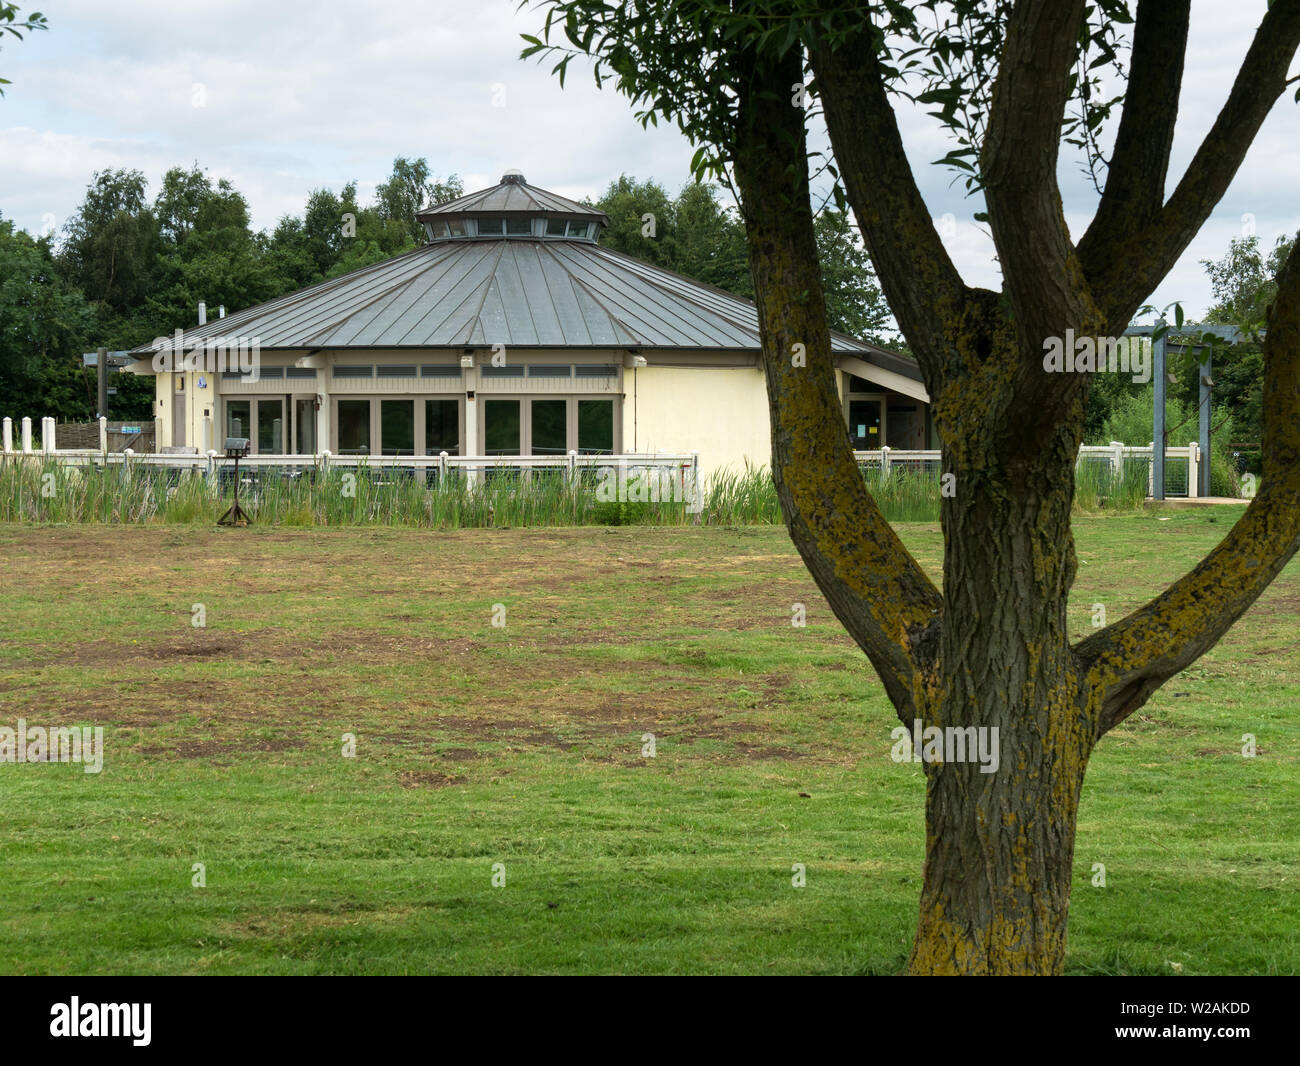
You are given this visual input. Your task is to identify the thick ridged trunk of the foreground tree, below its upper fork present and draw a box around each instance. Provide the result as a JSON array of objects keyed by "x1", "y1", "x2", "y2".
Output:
[{"x1": 909, "y1": 400, "x2": 1096, "y2": 974}]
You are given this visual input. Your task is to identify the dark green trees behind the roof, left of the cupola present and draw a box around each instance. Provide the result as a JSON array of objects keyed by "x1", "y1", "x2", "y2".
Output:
[{"x1": 0, "y1": 156, "x2": 460, "y2": 421}]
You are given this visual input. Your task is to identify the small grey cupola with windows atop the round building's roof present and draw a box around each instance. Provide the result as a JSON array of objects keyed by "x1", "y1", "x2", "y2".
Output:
[{"x1": 415, "y1": 170, "x2": 610, "y2": 242}]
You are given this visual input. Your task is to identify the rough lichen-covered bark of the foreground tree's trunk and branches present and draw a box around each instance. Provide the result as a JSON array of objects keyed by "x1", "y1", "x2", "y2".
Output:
[{"x1": 735, "y1": 0, "x2": 1300, "y2": 974}]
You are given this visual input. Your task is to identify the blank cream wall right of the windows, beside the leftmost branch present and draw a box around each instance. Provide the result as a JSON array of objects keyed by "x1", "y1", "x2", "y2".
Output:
[{"x1": 623, "y1": 365, "x2": 772, "y2": 478}]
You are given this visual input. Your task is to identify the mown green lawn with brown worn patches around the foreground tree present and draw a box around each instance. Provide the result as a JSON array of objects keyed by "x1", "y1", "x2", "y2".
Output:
[{"x1": 0, "y1": 508, "x2": 1300, "y2": 974}]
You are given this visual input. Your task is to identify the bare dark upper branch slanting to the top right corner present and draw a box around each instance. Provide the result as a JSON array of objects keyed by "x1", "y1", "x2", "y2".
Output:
[{"x1": 1088, "y1": 0, "x2": 1300, "y2": 325}]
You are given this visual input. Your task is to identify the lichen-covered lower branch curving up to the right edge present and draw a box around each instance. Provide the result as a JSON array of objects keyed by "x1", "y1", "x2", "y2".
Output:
[{"x1": 1075, "y1": 235, "x2": 1300, "y2": 736}]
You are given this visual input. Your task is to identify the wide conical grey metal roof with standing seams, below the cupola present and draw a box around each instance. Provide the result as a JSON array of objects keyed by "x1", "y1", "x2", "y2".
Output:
[{"x1": 137, "y1": 238, "x2": 897, "y2": 358}]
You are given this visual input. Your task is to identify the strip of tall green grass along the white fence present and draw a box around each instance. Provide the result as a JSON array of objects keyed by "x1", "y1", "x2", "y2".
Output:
[{"x1": 0, "y1": 456, "x2": 1147, "y2": 529}]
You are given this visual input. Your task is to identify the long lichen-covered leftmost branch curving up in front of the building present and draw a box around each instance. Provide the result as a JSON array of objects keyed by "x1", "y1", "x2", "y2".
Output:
[{"x1": 735, "y1": 43, "x2": 943, "y2": 723}]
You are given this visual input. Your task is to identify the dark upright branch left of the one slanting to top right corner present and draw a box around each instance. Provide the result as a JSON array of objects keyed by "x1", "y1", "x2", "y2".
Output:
[{"x1": 1078, "y1": 0, "x2": 1192, "y2": 287}]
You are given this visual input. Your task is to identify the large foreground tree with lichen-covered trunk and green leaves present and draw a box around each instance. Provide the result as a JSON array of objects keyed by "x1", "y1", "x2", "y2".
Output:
[{"x1": 524, "y1": 0, "x2": 1300, "y2": 974}]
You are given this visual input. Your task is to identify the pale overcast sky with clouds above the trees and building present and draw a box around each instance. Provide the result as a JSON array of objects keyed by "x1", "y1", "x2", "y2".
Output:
[{"x1": 0, "y1": 0, "x2": 1300, "y2": 317}]
